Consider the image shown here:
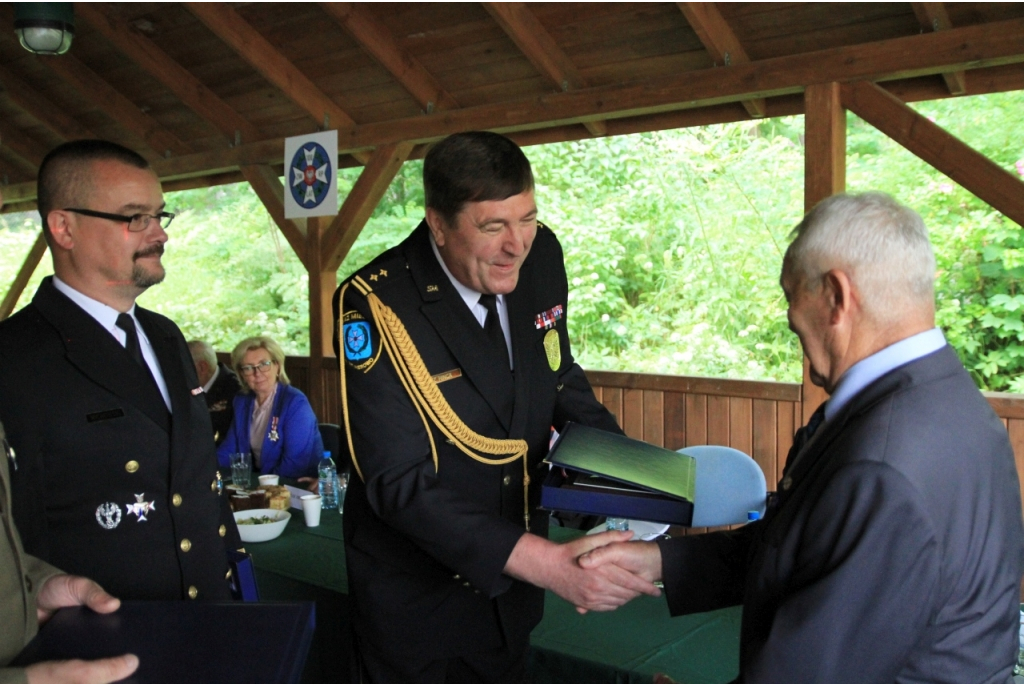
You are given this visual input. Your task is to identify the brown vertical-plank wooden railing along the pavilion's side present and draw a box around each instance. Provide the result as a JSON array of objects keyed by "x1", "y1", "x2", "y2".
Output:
[{"x1": 276, "y1": 356, "x2": 1024, "y2": 507}]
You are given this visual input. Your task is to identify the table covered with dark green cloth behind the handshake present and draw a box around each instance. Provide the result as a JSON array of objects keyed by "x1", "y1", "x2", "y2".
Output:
[{"x1": 246, "y1": 510, "x2": 740, "y2": 683}]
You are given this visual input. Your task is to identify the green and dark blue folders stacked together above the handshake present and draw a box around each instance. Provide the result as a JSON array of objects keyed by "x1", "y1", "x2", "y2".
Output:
[{"x1": 541, "y1": 422, "x2": 696, "y2": 525}]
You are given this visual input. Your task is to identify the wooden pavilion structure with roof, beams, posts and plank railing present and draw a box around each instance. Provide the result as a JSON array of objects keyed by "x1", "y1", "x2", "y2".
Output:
[{"x1": 0, "y1": 3, "x2": 1024, "y2": 516}]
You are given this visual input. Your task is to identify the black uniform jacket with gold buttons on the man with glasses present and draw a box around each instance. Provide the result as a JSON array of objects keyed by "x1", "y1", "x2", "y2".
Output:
[{"x1": 0, "y1": 279, "x2": 240, "y2": 599}]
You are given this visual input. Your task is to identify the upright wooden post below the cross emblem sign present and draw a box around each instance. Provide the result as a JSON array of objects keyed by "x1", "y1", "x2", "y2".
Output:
[{"x1": 305, "y1": 217, "x2": 338, "y2": 423}]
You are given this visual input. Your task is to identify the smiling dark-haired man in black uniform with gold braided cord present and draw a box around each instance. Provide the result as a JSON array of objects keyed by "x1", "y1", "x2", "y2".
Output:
[{"x1": 334, "y1": 133, "x2": 657, "y2": 682}]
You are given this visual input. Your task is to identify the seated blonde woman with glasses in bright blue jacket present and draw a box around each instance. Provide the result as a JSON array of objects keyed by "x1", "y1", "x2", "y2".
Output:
[{"x1": 217, "y1": 336, "x2": 324, "y2": 478}]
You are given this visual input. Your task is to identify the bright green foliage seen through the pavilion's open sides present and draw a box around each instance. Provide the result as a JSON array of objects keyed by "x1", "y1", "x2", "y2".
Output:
[{"x1": 0, "y1": 91, "x2": 1024, "y2": 392}]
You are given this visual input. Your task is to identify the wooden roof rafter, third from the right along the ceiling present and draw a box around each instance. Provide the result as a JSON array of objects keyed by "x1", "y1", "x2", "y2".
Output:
[{"x1": 483, "y1": 2, "x2": 607, "y2": 135}]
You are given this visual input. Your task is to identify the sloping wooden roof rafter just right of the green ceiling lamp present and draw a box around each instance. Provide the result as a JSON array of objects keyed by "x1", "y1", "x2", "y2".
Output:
[{"x1": 75, "y1": 2, "x2": 264, "y2": 143}]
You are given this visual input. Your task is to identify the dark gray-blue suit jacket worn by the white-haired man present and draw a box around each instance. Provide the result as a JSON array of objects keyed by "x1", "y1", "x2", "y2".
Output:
[{"x1": 662, "y1": 346, "x2": 1024, "y2": 683}]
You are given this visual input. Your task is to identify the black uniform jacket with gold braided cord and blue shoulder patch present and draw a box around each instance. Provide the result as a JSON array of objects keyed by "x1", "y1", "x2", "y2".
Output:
[{"x1": 334, "y1": 222, "x2": 620, "y2": 663}]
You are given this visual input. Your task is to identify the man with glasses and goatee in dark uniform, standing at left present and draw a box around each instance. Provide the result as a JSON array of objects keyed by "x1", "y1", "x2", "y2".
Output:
[{"x1": 0, "y1": 140, "x2": 239, "y2": 599}]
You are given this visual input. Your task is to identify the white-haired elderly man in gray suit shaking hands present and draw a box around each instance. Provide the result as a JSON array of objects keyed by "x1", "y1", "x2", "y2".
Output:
[{"x1": 580, "y1": 192, "x2": 1024, "y2": 683}]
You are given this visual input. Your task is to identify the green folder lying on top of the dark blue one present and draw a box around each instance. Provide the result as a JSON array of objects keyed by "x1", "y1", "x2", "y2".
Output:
[{"x1": 547, "y1": 422, "x2": 696, "y2": 503}]
